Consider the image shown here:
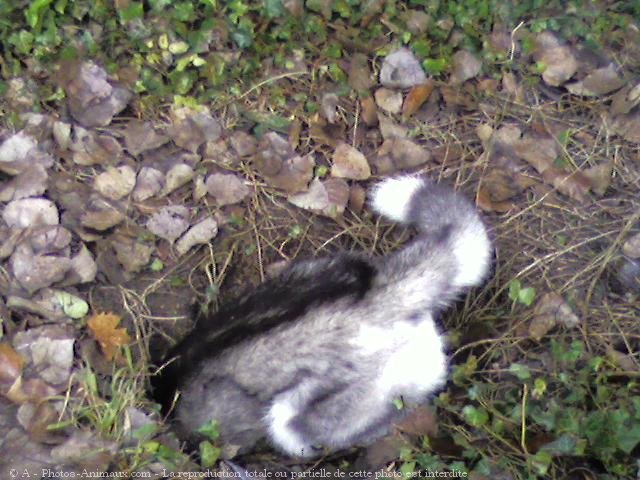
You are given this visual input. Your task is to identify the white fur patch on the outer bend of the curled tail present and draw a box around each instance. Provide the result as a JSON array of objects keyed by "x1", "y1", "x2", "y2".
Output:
[{"x1": 453, "y1": 220, "x2": 491, "y2": 287}]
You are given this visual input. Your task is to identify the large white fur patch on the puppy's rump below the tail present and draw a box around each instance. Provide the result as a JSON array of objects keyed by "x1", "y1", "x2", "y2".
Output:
[{"x1": 353, "y1": 315, "x2": 447, "y2": 401}]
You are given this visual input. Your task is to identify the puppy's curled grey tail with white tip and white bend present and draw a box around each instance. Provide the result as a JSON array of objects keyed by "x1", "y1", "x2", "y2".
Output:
[{"x1": 371, "y1": 176, "x2": 493, "y2": 305}]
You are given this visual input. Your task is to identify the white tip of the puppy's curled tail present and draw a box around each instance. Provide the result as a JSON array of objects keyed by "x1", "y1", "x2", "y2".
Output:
[{"x1": 371, "y1": 175, "x2": 424, "y2": 222}]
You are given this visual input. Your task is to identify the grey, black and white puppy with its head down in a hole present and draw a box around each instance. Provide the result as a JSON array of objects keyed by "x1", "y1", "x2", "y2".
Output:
[{"x1": 154, "y1": 176, "x2": 492, "y2": 457}]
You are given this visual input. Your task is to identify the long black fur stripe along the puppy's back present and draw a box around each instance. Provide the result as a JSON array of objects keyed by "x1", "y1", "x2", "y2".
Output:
[{"x1": 152, "y1": 254, "x2": 376, "y2": 414}]
